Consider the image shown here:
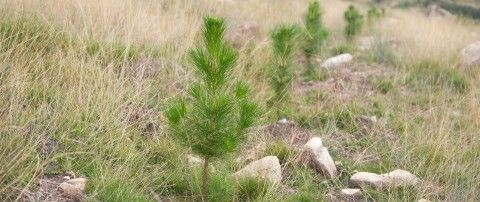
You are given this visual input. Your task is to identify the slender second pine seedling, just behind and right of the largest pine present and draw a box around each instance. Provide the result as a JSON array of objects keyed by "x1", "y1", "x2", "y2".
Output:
[{"x1": 269, "y1": 25, "x2": 297, "y2": 119}]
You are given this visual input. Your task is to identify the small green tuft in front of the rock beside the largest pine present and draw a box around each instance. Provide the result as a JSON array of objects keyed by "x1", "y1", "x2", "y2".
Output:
[{"x1": 237, "y1": 177, "x2": 272, "y2": 201}]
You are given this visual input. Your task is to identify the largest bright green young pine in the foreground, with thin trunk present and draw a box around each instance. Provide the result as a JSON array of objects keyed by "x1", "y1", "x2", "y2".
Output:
[{"x1": 166, "y1": 17, "x2": 258, "y2": 201}]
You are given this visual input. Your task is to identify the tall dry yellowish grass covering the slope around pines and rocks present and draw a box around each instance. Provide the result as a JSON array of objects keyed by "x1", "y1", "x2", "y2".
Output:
[{"x1": 0, "y1": 0, "x2": 480, "y2": 201}]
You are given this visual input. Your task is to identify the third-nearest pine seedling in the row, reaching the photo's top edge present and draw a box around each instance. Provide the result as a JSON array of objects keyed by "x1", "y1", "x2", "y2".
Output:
[{"x1": 303, "y1": 0, "x2": 329, "y2": 80}]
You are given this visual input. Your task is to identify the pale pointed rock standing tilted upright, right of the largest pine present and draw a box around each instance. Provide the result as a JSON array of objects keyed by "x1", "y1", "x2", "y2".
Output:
[{"x1": 304, "y1": 137, "x2": 337, "y2": 179}]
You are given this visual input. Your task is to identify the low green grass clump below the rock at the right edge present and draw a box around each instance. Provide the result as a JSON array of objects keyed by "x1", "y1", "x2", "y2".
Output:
[{"x1": 405, "y1": 60, "x2": 469, "y2": 93}]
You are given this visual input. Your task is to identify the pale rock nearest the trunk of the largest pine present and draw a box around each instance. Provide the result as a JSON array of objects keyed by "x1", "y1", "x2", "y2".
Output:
[{"x1": 233, "y1": 156, "x2": 282, "y2": 183}]
